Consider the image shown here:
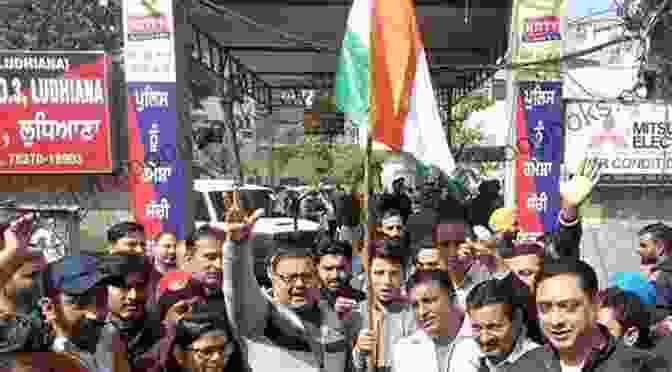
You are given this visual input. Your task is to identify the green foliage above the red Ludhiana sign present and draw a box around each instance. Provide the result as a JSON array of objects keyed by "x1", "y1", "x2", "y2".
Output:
[{"x1": 0, "y1": 0, "x2": 123, "y2": 51}]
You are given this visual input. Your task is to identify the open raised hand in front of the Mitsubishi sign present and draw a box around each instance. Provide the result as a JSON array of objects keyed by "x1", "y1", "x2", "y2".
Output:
[{"x1": 560, "y1": 159, "x2": 603, "y2": 208}]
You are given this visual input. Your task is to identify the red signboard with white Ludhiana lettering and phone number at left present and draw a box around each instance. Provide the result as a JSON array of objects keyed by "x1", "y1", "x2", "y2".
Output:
[{"x1": 0, "y1": 51, "x2": 113, "y2": 174}]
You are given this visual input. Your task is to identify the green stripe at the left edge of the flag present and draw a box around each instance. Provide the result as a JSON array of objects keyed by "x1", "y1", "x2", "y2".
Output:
[{"x1": 336, "y1": 31, "x2": 369, "y2": 127}]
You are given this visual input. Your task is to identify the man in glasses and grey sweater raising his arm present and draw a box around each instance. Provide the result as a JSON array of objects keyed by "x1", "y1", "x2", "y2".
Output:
[{"x1": 215, "y1": 211, "x2": 356, "y2": 372}]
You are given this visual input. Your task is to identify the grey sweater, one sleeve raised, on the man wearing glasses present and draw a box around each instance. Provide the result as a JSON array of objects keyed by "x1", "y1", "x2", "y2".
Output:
[{"x1": 223, "y1": 241, "x2": 361, "y2": 372}]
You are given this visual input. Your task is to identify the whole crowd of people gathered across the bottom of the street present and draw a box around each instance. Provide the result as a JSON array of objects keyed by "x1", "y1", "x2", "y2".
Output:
[{"x1": 0, "y1": 158, "x2": 672, "y2": 372}]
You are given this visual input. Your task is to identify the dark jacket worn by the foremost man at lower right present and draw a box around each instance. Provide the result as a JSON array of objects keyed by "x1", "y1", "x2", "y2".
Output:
[{"x1": 511, "y1": 327, "x2": 669, "y2": 372}]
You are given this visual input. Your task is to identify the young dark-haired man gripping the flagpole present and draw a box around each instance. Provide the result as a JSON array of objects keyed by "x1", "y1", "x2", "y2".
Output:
[{"x1": 354, "y1": 240, "x2": 415, "y2": 370}]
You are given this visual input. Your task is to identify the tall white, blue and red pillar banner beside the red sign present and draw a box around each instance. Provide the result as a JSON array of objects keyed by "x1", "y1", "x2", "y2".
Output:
[{"x1": 123, "y1": 0, "x2": 185, "y2": 240}]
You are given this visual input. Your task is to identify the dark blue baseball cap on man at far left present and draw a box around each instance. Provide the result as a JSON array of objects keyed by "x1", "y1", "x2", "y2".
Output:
[{"x1": 49, "y1": 255, "x2": 99, "y2": 295}]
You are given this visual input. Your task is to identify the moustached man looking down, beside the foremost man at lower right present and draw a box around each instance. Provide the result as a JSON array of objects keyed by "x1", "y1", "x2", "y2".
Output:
[{"x1": 449, "y1": 279, "x2": 546, "y2": 372}]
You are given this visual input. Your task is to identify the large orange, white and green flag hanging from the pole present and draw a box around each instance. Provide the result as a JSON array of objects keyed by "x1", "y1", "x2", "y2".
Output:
[{"x1": 336, "y1": 0, "x2": 455, "y2": 175}]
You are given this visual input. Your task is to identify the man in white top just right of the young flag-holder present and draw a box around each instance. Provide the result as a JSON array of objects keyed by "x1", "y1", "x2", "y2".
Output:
[{"x1": 391, "y1": 271, "x2": 475, "y2": 372}]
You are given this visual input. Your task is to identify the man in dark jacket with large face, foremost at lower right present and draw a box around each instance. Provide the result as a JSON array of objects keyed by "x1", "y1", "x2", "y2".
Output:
[{"x1": 535, "y1": 258, "x2": 669, "y2": 372}]
